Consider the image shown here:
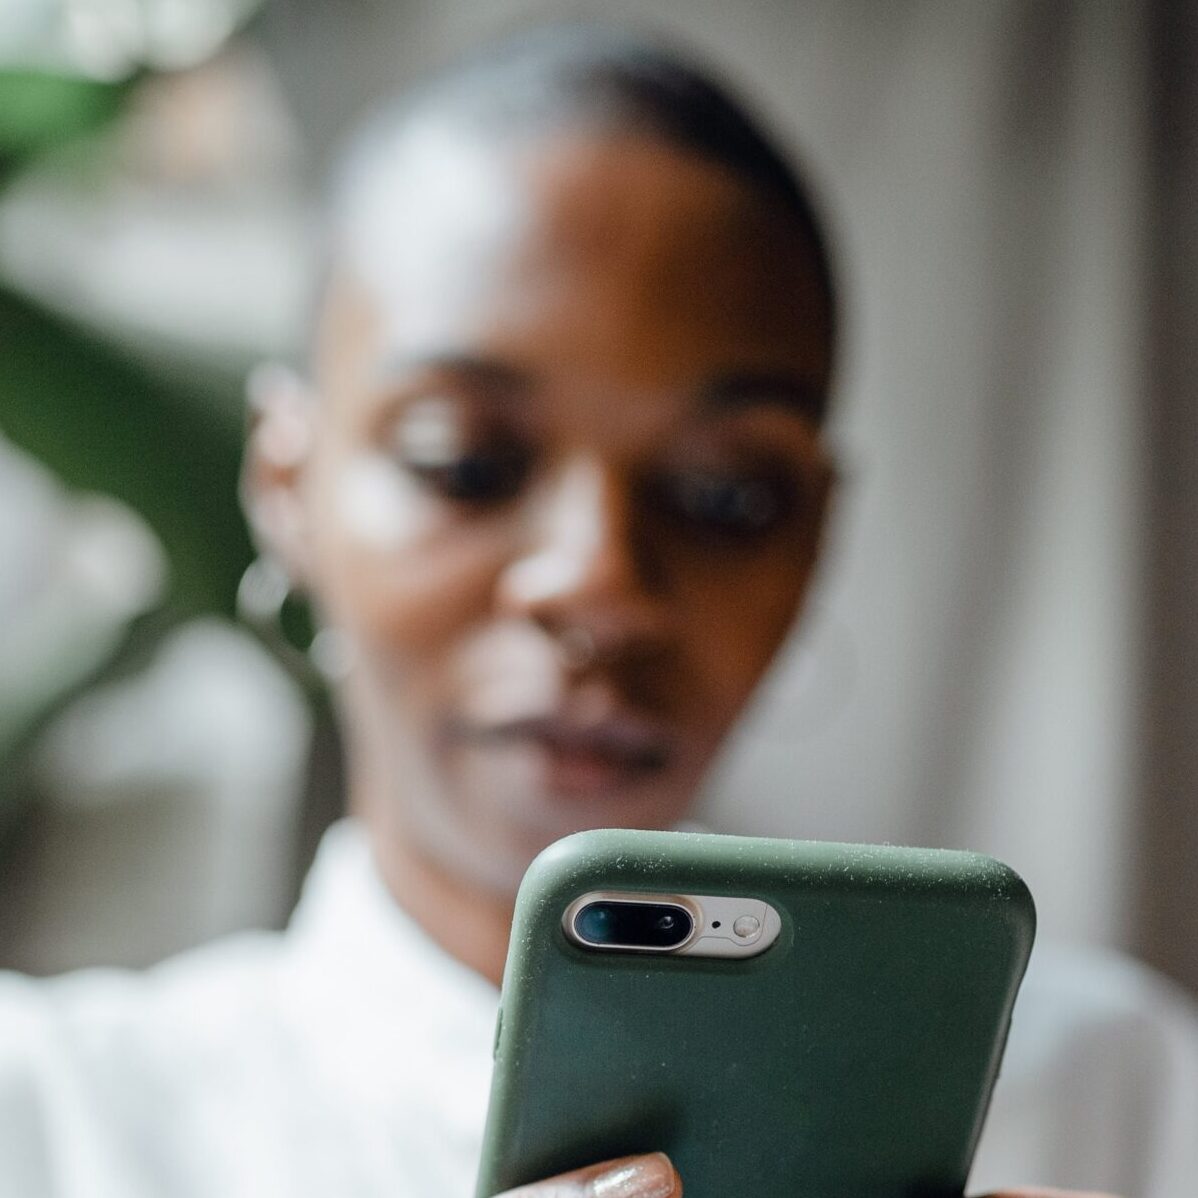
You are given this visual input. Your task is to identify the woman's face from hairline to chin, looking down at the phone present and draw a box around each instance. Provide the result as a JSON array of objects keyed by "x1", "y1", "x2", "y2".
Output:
[{"x1": 252, "y1": 135, "x2": 830, "y2": 890}]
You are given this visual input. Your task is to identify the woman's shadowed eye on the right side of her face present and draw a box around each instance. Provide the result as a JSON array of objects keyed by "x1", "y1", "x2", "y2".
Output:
[{"x1": 654, "y1": 470, "x2": 795, "y2": 537}]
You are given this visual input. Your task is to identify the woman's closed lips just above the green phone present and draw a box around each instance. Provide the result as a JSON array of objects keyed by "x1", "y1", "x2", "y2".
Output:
[{"x1": 454, "y1": 714, "x2": 673, "y2": 797}]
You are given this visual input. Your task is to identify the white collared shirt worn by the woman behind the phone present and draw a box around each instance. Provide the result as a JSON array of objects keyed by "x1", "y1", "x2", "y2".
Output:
[{"x1": 0, "y1": 821, "x2": 1198, "y2": 1198}]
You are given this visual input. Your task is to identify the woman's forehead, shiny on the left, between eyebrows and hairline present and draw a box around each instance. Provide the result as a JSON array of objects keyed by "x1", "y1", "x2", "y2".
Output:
[{"x1": 323, "y1": 133, "x2": 830, "y2": 395}]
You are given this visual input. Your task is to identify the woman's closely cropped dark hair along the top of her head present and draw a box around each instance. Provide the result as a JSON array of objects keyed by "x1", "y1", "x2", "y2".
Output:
[{"x1": 323, "y1": 23, "x2": 837, "y2": 419}]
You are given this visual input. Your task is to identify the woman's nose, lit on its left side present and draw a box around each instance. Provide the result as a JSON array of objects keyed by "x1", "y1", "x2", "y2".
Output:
[{"x1": 500, "y1": 460, "x2": 668, "y2": 658}]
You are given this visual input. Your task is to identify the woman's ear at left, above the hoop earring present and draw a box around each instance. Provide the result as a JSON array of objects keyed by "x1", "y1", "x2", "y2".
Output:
[{"x1": 241, "y1": 363, "x2": 315, "y2": 586}]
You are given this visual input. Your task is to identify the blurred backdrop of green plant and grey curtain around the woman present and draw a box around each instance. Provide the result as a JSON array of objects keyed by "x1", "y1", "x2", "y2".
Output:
[{"x1": 0, "y1": 0, "x2": 1198, "y2": 990}]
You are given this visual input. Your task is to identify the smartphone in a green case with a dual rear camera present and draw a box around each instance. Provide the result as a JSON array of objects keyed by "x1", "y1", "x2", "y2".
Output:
[{"x1": 477, "y1": 829, "x2": 1035, "y2": 1198}]
